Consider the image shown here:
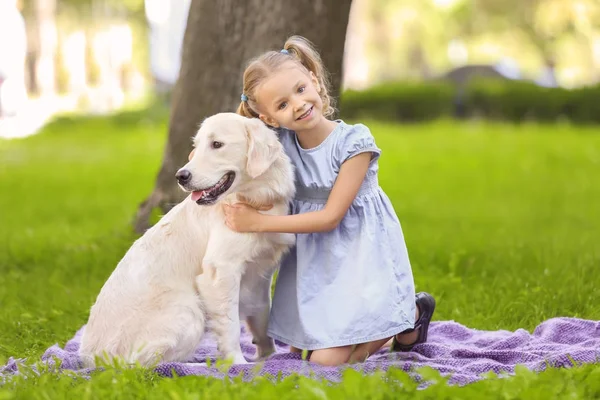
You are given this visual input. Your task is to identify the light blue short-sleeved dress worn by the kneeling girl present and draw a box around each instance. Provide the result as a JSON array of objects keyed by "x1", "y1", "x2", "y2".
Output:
[{"x1": 268, "y1": 120, "x2": 416, "y2": 350}]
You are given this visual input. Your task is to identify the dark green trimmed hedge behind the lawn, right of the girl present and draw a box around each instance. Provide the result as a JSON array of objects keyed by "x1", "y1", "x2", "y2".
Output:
[{"x1": 340, "y1": 79, "x2": 600, "y2": 124}]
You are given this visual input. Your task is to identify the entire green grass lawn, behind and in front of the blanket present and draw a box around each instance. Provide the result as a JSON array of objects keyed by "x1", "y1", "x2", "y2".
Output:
[{"x1": 0, "y1": 114, "x2": 600, "y2": 400}]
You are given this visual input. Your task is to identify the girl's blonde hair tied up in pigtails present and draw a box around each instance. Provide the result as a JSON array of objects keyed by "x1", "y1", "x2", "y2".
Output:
[{"x1": 237, "y1": 36, "x2": 335, "y2": 118}]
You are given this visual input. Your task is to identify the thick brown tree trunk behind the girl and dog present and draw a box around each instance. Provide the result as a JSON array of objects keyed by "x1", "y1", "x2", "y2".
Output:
[{"x1": 135, "y1": 0, "x2": 351, "y2": 233}]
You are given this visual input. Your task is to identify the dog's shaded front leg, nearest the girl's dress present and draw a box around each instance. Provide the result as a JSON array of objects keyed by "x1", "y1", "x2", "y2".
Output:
[{"x1": 246, "y1": 279, "x2": 275, "y2": 360}]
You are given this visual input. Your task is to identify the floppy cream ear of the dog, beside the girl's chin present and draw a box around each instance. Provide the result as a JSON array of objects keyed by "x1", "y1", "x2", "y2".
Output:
[{"x1": 246, "y1": 118, "x2": 280, "y2": 179}]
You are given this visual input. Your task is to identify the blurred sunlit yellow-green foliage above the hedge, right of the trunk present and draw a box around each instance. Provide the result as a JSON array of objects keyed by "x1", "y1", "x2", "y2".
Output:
[{"x1": 358, "y1": 0, "x2": 600, "y2": 86}]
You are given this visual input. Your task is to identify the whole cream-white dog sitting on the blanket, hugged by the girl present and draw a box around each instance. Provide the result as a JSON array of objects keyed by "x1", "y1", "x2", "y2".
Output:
[{"x1": 80, "y1": 113, "x2": 294, "y2": 366}]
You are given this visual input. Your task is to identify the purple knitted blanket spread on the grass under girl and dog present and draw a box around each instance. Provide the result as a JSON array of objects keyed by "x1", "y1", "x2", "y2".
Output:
[{"x1": 0, "y1": 318, "x2": 600, "y2": 385}]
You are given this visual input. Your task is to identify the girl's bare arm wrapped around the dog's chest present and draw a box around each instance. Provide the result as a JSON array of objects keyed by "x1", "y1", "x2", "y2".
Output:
[{"x1": 225, "y1": 152, "x2": 371, "y2": 233}]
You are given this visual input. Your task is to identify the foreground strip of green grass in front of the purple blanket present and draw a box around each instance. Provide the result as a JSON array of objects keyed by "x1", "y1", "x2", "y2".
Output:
[{"x1": 0, "y1": 365, "x2": 600, "y2": 400}]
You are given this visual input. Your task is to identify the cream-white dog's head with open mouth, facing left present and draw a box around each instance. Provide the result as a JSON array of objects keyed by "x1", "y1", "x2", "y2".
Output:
[{"x1": 175, "y1": 113, "x2": 282, "y2": 205}]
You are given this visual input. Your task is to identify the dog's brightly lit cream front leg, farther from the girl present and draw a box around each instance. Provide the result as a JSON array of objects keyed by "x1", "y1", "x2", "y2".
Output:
[{"x1": 196, "y1": 263, "x2": 247, "y2": 364}]
